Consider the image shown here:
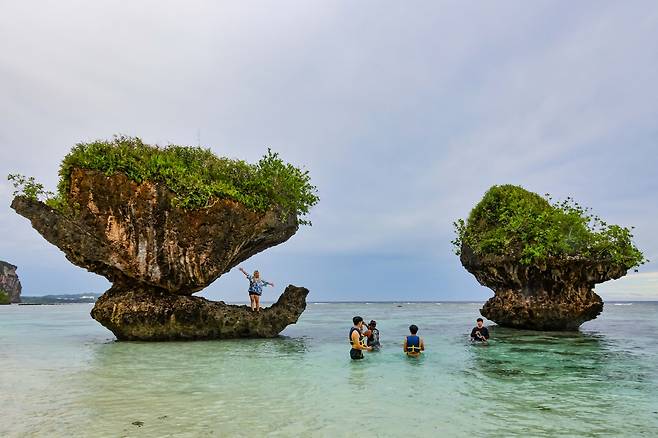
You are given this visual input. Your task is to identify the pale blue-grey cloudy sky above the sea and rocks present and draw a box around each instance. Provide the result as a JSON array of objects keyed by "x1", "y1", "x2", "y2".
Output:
[{"x1": 0, "y1": 0, "x2": 658, "y2": 301}]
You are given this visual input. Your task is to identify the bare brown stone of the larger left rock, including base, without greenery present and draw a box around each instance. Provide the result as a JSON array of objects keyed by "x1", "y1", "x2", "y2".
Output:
[{"x1": 11, "y1": 169, "x2": 306, "y2": 340}]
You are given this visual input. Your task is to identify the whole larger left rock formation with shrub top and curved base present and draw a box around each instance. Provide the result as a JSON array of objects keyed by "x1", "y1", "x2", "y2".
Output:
[{"x1": 11, "y1": 137, "x2": 317, "y2": 340}]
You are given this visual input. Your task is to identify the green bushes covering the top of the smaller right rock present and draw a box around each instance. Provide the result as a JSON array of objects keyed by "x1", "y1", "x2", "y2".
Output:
[{"x1": 452, "y1": 185, "x2": 648, "y2": 269}]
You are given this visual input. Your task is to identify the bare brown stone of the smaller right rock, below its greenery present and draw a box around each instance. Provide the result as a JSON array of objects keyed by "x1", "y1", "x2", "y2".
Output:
[{"x1": 460, "y1": 245, "x2": 628, "y2": 330}]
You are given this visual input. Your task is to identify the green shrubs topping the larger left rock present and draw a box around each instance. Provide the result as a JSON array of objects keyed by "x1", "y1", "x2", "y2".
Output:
[{"x1": 10, "y1": 136, "x2": 319, "y2": 224}]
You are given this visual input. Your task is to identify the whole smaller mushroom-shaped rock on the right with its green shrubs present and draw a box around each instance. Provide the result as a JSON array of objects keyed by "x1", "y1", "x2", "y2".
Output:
[{"x1": 453, "y1": 185, "x2": 645, "y2": 330}]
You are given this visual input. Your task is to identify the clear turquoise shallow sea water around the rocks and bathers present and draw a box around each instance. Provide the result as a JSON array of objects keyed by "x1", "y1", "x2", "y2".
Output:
[{"x1": 0, "y1": 303, "x2": 658, "y2": 437}]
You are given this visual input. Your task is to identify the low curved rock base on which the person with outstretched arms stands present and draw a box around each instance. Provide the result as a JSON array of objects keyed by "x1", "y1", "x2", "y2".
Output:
[{"x1": 91, "y1": 284, "x2": 308, "y2": 341}]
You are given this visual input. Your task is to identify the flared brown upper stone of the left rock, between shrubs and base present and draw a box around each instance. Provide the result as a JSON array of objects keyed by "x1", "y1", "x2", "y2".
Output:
[{"x1": 11, "y1": 169, "x2": 298, "y2": 295}]
